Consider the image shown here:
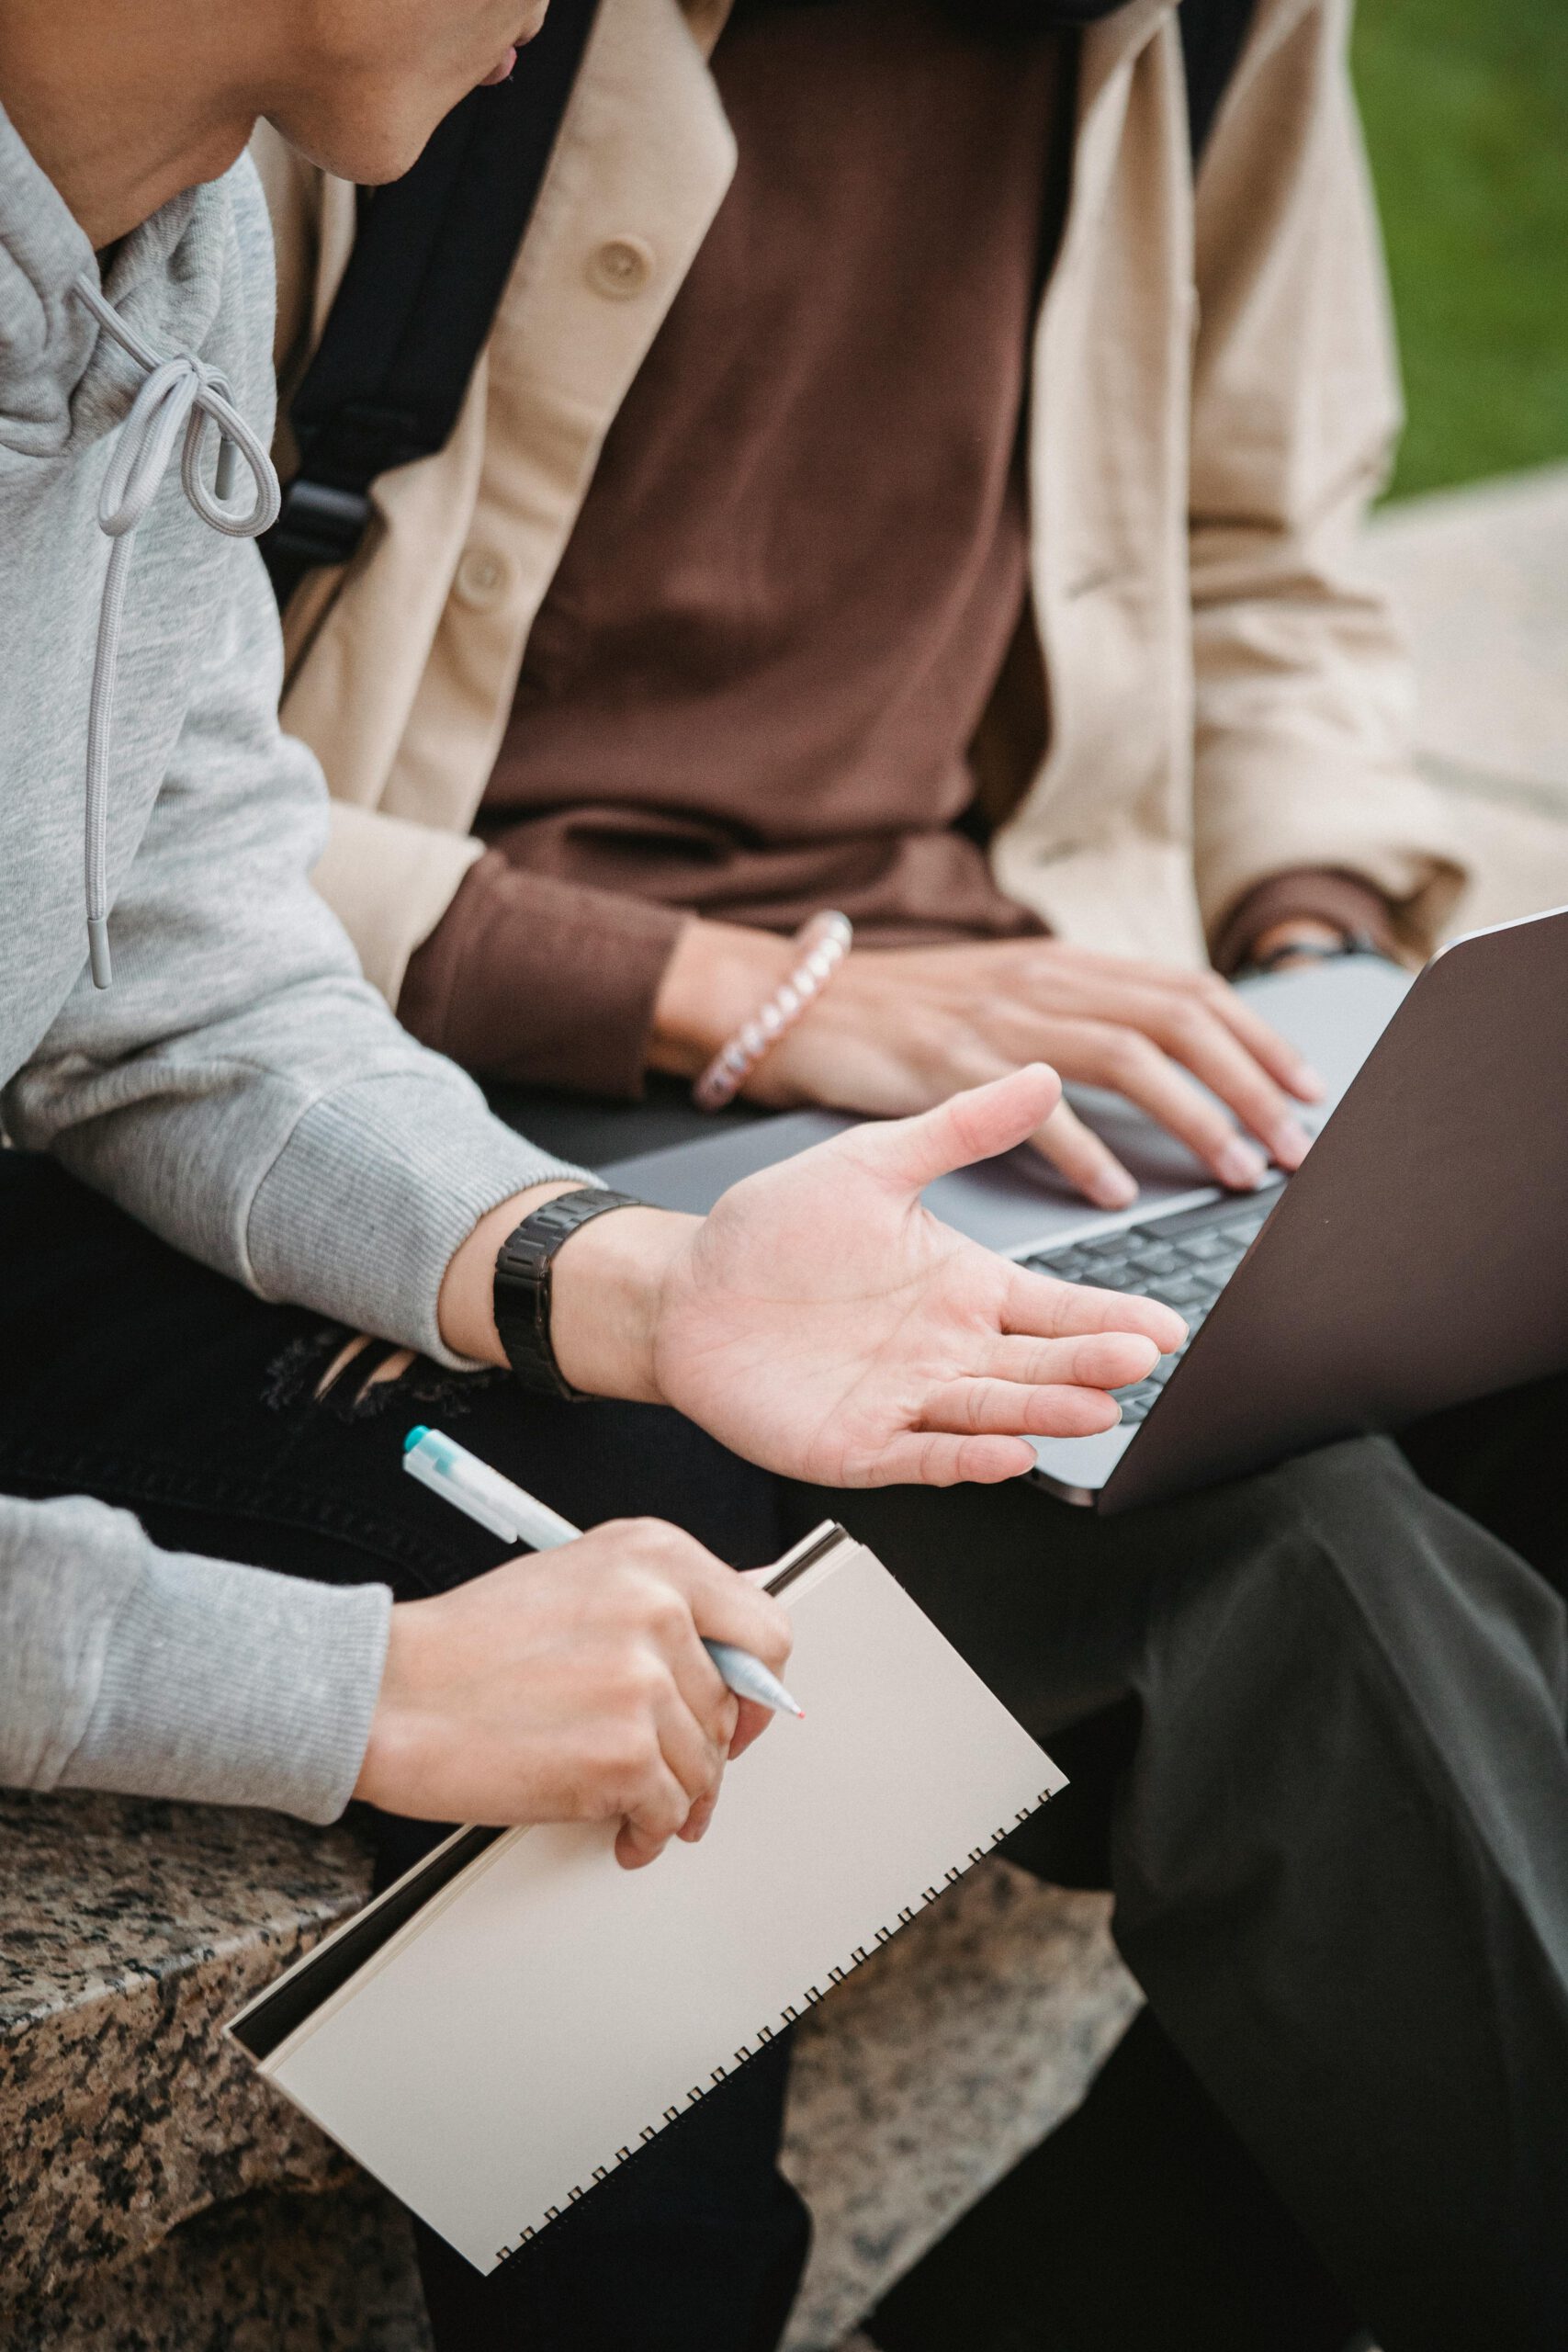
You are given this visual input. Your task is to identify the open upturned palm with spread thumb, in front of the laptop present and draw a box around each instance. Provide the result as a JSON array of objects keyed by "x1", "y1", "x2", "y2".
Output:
[{"x1": 656, "y1": 1063, "x2": 1185, "y2": 1487}]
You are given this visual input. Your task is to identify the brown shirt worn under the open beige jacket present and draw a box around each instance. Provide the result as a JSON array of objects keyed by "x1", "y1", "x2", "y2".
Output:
[{"x1": 402, "y1": 0, "x2": 1058, "y2": 1091}]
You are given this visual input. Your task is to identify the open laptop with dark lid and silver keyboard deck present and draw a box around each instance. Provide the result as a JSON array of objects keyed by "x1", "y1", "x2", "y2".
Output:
[{"x1": 604, "y1": 908, "x2": 1568, "y2": 1512}]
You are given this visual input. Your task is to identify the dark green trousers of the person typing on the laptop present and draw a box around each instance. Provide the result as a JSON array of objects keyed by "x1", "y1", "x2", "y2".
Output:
[{"x1": 837, "y1": 1411, "x2": 1568, "y2": 2352}]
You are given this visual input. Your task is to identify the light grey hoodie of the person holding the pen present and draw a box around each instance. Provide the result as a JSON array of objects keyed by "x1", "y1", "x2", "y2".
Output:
[{"x1": 0, "y1": 115, "x2": 587, "y2": 1820}]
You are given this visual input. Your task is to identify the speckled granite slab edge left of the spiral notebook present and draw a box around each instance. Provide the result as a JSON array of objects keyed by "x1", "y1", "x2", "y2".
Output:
[{"x1": 0, "y1": 1792, "x2": 369, "y2": 2304}]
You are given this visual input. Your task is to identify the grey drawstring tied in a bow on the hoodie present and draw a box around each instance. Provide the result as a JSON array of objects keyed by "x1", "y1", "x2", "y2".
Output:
[{"x1": 75, "y1": 273, "x2": 280, "y2": 988}]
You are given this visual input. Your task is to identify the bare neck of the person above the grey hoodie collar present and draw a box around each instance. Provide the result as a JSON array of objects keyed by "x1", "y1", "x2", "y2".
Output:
[{"x1": 0, "y1": 0, "x2": 273, "y2": 249}]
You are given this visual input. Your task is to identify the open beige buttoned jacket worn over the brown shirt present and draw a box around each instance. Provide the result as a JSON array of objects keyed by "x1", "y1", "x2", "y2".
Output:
[{"x1": 259, "y1": 0, "x2": 1462, "y2": 1000}]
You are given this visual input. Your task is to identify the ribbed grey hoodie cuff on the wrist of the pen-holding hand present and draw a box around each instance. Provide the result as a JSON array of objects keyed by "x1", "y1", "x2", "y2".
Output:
[{"x1": 59, "y1": 1545, "x2": 392, "y2": 1823}]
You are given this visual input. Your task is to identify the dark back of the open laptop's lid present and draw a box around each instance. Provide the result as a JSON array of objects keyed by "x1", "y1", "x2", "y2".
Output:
[{"x1": 1100, "y1": 910, "x2": 1568, "y2": 1510}]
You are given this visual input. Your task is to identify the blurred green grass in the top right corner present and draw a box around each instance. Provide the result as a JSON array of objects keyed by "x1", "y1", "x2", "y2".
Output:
[{"x1": 1354, "y1": 0, "x2": 1568, "y2": 496}]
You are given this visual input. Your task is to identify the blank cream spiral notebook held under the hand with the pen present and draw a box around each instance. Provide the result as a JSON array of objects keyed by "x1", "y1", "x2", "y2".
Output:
[{"x1": 228, "y1": 1526, "x2": 1063, "y2": 2272}]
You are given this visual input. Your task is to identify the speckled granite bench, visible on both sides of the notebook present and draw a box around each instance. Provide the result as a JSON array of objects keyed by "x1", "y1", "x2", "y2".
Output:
[{"x1": 0, "y1": 1792, "x2": 1138, "y2": 2352}]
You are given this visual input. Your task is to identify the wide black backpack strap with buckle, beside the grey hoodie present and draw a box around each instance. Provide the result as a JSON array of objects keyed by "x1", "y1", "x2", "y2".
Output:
[{"x1": 261, "y1": 0, "x2": 597, "y2": 605}]
